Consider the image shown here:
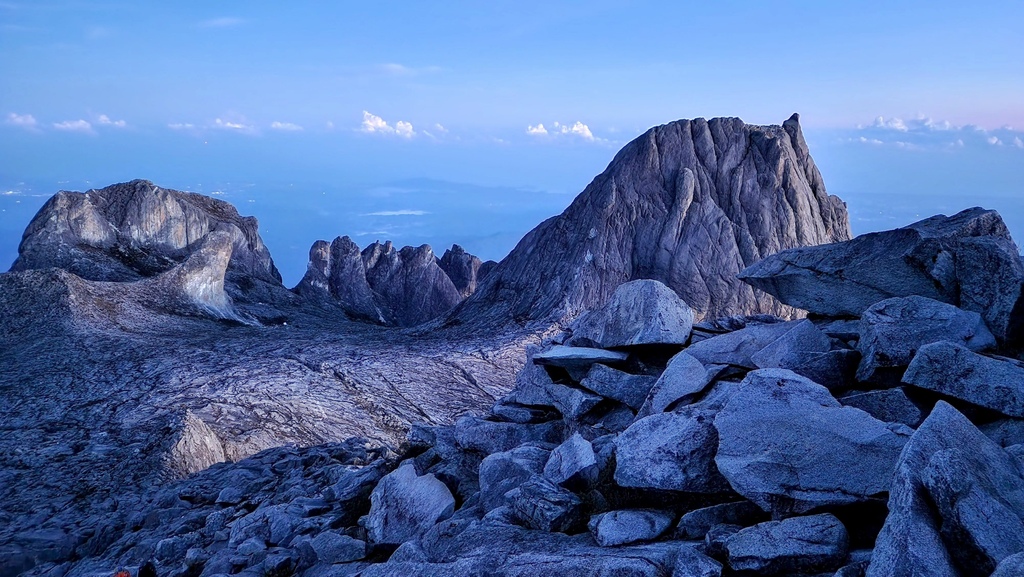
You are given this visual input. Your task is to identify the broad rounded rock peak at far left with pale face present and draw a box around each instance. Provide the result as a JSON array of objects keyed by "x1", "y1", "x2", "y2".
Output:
[{"x1": 11, "y1": 180, "x2": 281, "y2": 297}]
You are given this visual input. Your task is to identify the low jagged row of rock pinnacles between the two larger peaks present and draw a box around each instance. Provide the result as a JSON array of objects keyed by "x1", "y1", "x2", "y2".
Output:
[{"x1": 294, "y1": 237, "x2": 493, "y2": 327}]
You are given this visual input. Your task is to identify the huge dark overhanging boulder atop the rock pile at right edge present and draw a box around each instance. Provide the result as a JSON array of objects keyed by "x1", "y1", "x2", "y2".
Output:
[{"x1": 739, "y1": 208, "x2": 1024, "y2": 340}]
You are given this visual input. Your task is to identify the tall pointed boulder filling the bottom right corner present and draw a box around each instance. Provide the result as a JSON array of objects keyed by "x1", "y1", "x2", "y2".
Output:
[{"x1": 867, "y1": 401, "x2": 1024, "y2": 577}]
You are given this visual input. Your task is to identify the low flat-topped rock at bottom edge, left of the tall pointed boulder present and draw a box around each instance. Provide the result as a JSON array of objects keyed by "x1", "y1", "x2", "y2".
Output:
[{"x1": 725, "y1": 513, "x2": 850, "y2": 576}]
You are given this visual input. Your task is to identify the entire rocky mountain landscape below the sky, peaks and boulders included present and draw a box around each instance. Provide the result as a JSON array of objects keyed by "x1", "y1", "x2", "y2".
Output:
[{"x1": 0, "y1": 117, "x2": 1024, "y2": 577}]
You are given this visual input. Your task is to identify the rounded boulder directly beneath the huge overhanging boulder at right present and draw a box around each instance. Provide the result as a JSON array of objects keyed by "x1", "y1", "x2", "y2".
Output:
[{"x1": 857, "y1": 296, "x2": 995, "y2": 381}]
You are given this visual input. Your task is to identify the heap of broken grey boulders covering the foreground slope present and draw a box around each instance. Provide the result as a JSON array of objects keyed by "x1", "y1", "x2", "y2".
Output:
[{"x1": 22, "y1": 210, "x2": 1024, "y2": 577}]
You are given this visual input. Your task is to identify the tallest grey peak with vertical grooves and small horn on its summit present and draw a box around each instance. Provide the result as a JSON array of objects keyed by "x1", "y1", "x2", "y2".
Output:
[{"x1": 450, "y1": 115, "x2": 850, "y2": 323}]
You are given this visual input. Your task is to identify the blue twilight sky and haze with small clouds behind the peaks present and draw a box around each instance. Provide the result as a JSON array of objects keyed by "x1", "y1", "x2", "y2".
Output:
[{"x1": 0, "y1": 0, "x2": 1024, "y2": 285}]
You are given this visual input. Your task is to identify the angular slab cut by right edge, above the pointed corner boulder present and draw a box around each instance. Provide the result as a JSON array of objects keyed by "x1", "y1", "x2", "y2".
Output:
[{"x1": 903, "y1": 342, "x2": 1024, "y2": 417}]
